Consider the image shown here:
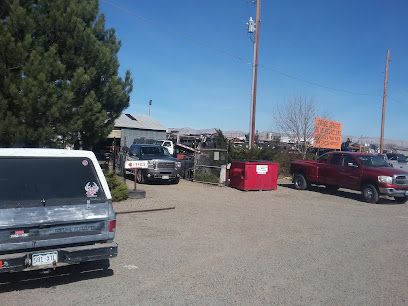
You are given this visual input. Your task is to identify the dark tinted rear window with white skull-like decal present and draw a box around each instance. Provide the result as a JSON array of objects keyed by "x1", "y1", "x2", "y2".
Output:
[{"x1": 0, "y1": 157, "x2": 106, "y2": 205}]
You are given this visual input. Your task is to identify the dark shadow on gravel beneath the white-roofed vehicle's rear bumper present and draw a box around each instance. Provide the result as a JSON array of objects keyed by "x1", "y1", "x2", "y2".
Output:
[{"x1": 0, "y1": 266, "x2": 114, "y2": 293}]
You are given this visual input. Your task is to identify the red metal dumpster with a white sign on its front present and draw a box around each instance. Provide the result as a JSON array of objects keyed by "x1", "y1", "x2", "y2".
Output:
[{"x1": 230, "y1": 161, "x2": 279, "y2": 190}]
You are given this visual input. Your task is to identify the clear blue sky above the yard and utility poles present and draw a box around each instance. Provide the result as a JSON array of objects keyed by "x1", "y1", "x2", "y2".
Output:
[{"x1": 100, "y1": 0, "x2": 408, "y2": 140}]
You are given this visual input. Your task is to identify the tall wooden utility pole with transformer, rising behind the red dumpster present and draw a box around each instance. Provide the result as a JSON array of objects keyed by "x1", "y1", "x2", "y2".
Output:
[{"x1": 248, "y1": 0, "x2": 261, "y2": 149}]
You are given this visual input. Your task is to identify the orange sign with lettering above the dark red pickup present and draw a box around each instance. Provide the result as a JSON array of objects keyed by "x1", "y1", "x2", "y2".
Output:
[{"x1": 313, "y1": 117, "x2": 341, "y2": 149}]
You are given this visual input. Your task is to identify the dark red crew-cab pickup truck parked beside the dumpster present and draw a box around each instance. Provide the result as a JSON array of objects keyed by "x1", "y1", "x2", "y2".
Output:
[{"x1": 291, "y1": 151, "x2": 408, "y2": 203}]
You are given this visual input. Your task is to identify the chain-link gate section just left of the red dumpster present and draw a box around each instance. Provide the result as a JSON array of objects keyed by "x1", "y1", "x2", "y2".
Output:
[{"x1": 193, "y1": 149, "x2": 228, "y2": 185}]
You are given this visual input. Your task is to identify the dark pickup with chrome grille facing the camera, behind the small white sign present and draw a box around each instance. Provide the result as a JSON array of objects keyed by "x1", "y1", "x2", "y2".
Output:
[{"x1": 119, "y1": 144, "x2": 181, "y2": 184}]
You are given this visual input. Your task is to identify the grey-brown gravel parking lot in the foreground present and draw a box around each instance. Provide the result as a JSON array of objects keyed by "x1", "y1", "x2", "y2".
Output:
[{"x1": 0, "y1": 181, "x2": 408, "y2": 305}]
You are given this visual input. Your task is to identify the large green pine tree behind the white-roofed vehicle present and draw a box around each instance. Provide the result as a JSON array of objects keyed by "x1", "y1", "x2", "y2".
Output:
[{"x1": 0, "y1": 0, "x2": 132, "y2": 148}]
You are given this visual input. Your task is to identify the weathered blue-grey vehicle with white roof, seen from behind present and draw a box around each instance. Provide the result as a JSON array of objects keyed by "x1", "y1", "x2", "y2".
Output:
[{"x1": 0, "y1": 149, "x2": 118, "y2": 272}]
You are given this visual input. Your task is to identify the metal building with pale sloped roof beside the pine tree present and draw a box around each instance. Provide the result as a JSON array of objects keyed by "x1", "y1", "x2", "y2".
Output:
[{"x1": 108, "y1": 113, "x2": 166, "y2": 147}]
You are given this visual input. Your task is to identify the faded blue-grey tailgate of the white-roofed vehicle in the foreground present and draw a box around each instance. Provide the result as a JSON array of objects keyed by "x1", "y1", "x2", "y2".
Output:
[{"x1": 0, "y1": 202, "x2": 114, "y2": 253}]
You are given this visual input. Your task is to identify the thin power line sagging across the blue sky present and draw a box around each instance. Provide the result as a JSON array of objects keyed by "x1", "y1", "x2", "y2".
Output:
[{"x1": 102, "y1": 0, "x2": 388, "y2": 98}]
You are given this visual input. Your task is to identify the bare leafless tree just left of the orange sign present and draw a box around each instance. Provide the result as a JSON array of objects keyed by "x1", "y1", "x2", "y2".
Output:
[{"x1": 274, "y1": 96, "x2": 316, "y2": 159}]
